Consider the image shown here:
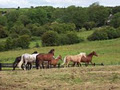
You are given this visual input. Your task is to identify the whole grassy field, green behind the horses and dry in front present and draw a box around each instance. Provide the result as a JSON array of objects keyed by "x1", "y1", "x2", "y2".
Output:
[{"x1": 0, "y1": 31, "x2": 120, "y2": 90}]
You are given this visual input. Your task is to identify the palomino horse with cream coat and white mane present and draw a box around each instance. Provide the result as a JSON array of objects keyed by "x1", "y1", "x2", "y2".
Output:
[{"x1": 62, "y1": 53, "x2": 86, "y2": 67}]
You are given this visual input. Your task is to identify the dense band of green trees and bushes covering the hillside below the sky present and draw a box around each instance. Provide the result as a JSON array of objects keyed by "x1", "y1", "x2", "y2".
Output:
[{"x1": 0, "y1": 3, "x2": 120, "y2": 50}]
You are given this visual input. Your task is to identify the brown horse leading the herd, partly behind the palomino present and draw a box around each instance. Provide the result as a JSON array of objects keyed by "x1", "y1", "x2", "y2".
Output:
[{"x1": 81, "y1": 51, "x2": 98, "y2": 66}]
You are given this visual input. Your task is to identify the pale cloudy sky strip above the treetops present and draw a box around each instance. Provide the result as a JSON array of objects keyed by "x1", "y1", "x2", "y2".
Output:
[{"x1": 0, "y1": 0, "x2": 120, "y2": 8}]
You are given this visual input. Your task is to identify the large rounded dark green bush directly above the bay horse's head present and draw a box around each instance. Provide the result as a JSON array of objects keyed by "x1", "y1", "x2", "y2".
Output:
[{"x1": 42, "y1": 31, "x2": 58, "y2": 46}]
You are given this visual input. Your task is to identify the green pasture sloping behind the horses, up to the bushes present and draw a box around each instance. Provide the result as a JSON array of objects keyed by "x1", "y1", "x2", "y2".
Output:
[{"x1": 0, "y1": 31, "x2": 120, "y2": 65}]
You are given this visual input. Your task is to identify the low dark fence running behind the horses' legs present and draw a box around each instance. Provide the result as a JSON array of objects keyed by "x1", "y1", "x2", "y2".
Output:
[{"x1": 0, "y1": 63, "x2": 104, "y2": 71}]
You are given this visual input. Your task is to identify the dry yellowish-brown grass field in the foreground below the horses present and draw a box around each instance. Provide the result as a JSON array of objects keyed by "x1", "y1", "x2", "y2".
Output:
[{"x1": 0, "y1": 66, "x2": 120, "y2": 90}]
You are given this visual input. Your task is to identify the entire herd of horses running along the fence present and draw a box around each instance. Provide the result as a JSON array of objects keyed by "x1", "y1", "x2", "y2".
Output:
[{"x1": 13, "y1": 49, "x2": 98, "y2": 70}]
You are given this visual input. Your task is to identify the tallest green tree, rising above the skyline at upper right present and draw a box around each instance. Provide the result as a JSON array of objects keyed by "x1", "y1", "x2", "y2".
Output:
[{"x1": 88, "y1": 5, "x2": 109, "y2": 27}]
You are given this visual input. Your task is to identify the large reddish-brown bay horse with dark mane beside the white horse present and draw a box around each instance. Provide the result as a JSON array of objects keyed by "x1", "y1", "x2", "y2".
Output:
[{"x1": 36, "y1": 49, "x2": 55, "y2": 69}]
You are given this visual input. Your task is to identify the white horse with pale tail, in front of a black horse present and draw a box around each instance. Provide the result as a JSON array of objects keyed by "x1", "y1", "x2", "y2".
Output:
[{"x1": 18, "y1": 53, "x2": 38, "y2": 70}]
